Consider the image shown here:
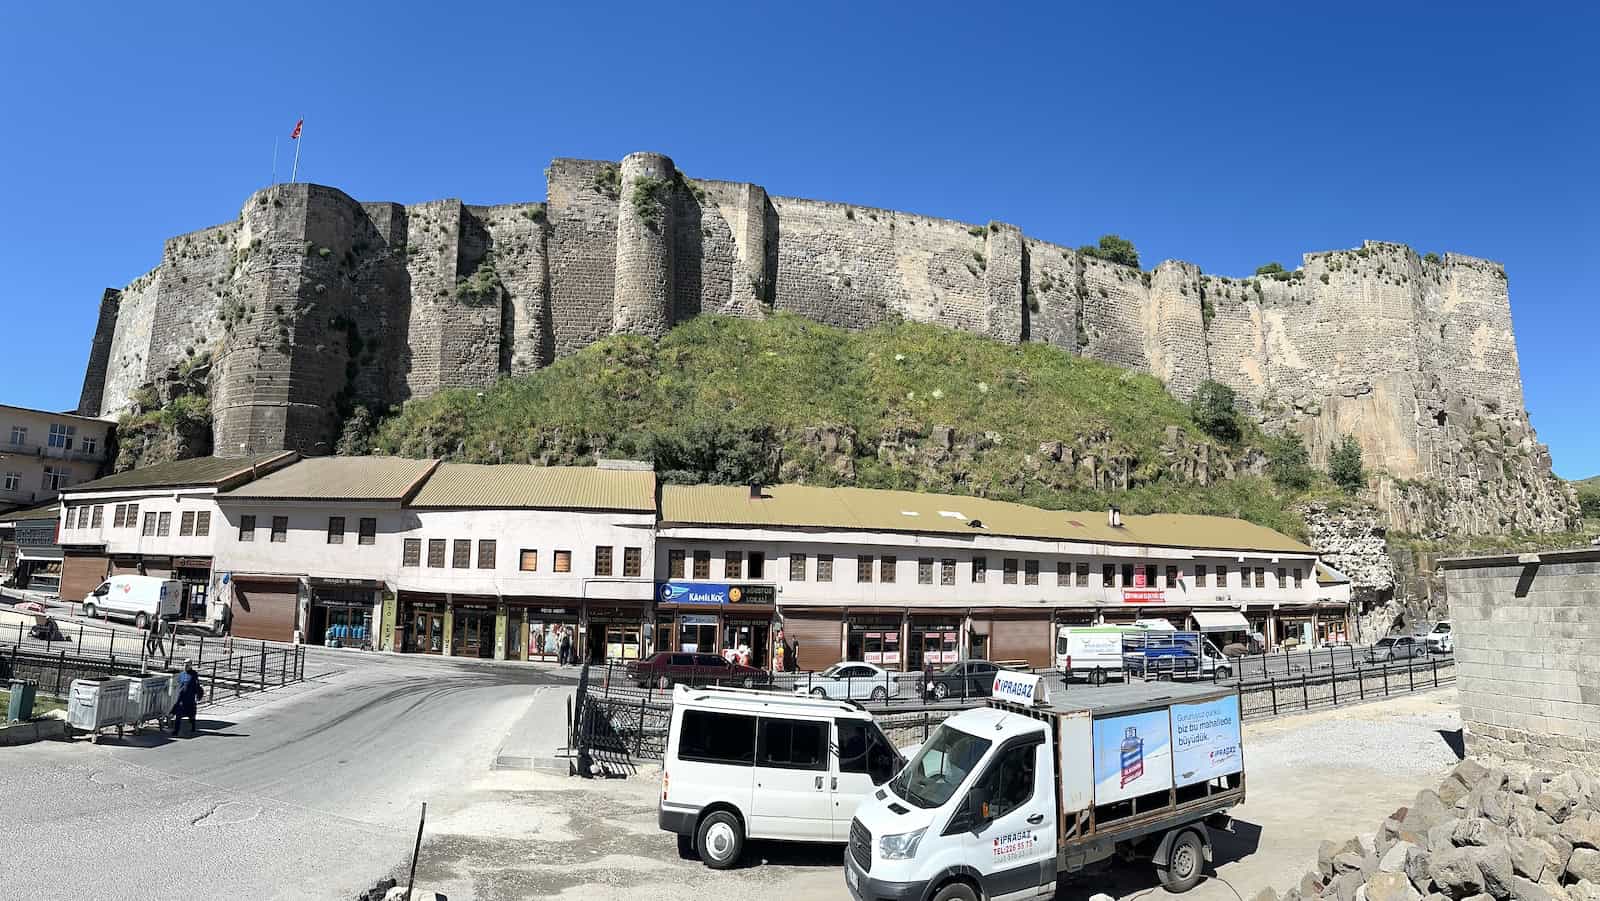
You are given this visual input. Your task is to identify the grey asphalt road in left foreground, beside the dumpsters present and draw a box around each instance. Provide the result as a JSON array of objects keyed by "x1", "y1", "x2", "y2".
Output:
[{"x1": 0, "y1": 655, "x2": 571, "y2": 901}]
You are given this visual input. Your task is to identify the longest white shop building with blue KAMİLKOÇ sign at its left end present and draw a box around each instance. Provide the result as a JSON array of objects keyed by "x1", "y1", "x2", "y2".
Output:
[{"x1": 656, "y1": 485, "x2": 1347, "y2": 669}]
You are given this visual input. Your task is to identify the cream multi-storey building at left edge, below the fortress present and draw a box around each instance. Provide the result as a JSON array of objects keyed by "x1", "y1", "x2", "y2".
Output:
[{"x1": 0, "y1": 405, "x2": 112, "y2": 511}]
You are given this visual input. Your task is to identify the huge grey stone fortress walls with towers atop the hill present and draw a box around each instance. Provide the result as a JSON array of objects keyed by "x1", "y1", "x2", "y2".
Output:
[{"x1": 78, "y1": 154, "x2": 1576, "y2": 533}]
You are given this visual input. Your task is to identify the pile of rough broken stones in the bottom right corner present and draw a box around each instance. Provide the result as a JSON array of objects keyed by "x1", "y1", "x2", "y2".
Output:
[{"x1": 1254, "y1": 760, "x2": 1600, "y2": 901}]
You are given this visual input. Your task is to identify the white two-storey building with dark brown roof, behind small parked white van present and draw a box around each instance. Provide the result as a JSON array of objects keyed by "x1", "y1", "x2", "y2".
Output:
[{"x1": 59, "y1": 451, "x2": 298, "y2": 619}]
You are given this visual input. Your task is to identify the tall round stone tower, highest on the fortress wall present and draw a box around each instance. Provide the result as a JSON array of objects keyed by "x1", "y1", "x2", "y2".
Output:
[{"x1": 611, "y1": 154, "x2": 677, "y2": 338}]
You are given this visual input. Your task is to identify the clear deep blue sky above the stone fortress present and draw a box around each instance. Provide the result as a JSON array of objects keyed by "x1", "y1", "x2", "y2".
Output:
[{"x1": 0, "y1": 2, "x2": 1600, "y2": 477}]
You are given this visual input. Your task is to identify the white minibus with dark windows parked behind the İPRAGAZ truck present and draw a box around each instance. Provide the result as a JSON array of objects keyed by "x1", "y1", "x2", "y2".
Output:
[{"x1": 658, "y1": 685, "x2": 906, "y2": 869}]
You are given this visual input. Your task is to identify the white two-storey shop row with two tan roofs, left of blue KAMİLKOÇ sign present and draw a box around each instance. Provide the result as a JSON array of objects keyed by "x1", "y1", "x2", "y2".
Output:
[{"x1": 218, "y1": 458, "x2": 654, "y2": 661}]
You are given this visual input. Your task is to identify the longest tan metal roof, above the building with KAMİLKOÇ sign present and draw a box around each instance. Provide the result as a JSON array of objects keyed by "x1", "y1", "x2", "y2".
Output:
[{"x1": 661, "y1": 485, "x2": 1314, "y2": 554}]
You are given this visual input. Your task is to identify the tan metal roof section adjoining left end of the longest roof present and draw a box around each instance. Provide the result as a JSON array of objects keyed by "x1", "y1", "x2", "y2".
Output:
[{"x1": 410, "y1": 463, "x2": 656, "y2": 512}]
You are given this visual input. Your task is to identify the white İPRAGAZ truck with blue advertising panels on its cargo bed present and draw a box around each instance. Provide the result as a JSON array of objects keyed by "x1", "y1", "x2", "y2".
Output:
[{"x1": 845, "y1": 672, "x2": 1245, "y2": 901}]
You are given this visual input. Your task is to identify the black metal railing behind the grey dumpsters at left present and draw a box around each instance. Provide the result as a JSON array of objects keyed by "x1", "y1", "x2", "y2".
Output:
[{"x1": 0, "y1": 643, "x2": 306, "y2": 701}]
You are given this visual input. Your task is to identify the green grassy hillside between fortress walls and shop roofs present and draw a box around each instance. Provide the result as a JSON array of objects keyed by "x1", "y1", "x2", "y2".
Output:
[{"x1": 373, "y1": 315, "x2": 1326, "y2": 533}]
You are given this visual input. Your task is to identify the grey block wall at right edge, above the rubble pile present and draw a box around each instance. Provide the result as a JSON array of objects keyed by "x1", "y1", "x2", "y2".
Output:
[{"x1": 1440, "y1": 551, "x2": 1600, "y2": 771}]
